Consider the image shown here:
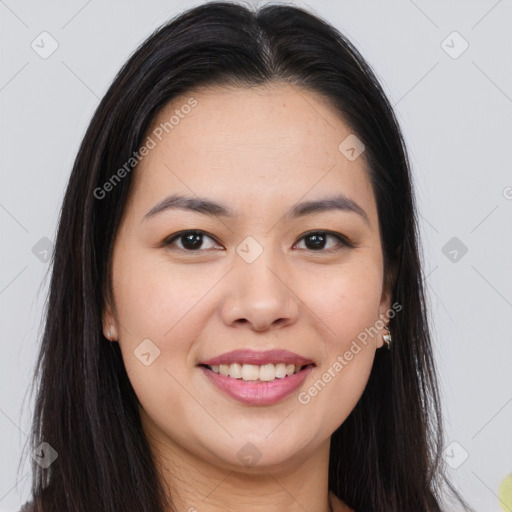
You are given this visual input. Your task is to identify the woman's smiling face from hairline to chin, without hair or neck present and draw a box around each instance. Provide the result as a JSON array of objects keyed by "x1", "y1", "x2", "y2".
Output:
[{"x1": 103, "y1": 84, "x2": 390, "y2": 476}]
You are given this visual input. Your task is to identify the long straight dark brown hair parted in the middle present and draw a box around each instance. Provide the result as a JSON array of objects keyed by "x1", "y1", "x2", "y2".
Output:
[{"x1": 23, "y1": 2, "x2": 472, "y2": 512}]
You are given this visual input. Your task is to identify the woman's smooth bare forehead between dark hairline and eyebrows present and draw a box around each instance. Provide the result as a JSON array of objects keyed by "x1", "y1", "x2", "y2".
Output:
[{"x1": 133, "y1": 84, "x2": 376, "y2": 226}]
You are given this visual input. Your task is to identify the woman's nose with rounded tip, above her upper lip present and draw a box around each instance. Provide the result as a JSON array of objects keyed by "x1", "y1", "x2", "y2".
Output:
[{"x1": 221, "y1": 247, "x2": 300, "y2": 332}]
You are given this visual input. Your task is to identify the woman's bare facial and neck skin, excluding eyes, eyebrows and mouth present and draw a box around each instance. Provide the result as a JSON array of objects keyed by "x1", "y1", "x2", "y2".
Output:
[{"x1": 103, "y1": 84, "x2": 391, "y2": 512}]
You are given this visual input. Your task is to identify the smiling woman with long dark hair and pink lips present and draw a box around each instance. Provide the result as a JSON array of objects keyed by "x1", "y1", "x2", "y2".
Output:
[{"x1": 23, "y1": 3, "x2": 472, "y2": 512}]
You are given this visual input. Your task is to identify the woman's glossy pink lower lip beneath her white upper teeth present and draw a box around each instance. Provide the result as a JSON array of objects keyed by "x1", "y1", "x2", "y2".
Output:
[{"x1": 200, "y1": 366, "x2": 313, "y2": 405}]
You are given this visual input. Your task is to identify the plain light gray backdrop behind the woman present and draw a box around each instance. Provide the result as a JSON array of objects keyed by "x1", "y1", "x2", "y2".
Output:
[{"x1": 0, "y1": 0, "x2": 512, "y2": 512}]
